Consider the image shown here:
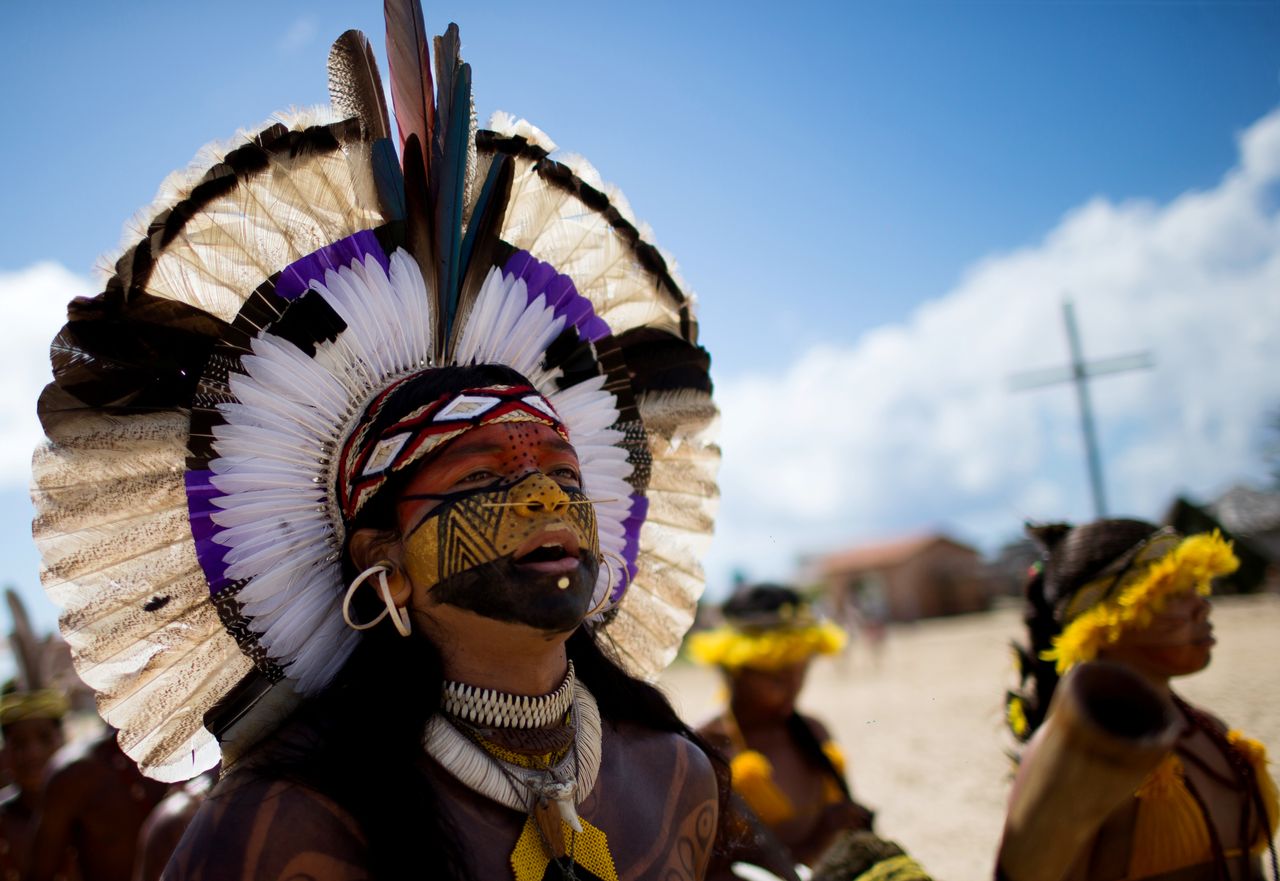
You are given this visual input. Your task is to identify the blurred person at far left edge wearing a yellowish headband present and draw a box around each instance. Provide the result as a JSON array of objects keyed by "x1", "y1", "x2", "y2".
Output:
[{"x1": 0, "y1": 689, "x2": 69, "y2": 881}]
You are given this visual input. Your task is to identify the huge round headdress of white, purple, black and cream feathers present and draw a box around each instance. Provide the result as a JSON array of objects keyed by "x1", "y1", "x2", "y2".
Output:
[{"x1": 32, "y1": 0, "x2": 719, "y2": 780}]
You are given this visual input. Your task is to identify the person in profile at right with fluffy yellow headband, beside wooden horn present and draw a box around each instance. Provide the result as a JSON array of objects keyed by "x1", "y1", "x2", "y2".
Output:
[{"x1": 997, "y1": 520, "x2": 1280, "y2": 881}]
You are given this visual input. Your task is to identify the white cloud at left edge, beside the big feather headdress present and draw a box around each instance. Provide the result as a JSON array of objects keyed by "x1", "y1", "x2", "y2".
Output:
[{"x1": 0, "y1": 263, "x2": 91, "y2": 488}]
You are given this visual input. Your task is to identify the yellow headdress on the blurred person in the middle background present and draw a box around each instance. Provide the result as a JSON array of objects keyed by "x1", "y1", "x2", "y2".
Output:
[{"x1": 689, "y1": 607, "x2": 849, "y2": 670}]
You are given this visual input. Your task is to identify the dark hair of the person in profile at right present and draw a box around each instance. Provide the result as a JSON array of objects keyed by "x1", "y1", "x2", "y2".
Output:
[{"x1": 1005, "y1": 519, "x2": 1158, "y2": 741}]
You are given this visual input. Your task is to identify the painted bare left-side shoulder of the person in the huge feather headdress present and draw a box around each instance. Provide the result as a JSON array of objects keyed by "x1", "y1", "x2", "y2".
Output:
[{"x1": 163, "y1": 773, "x2": 369, "y2": 881}]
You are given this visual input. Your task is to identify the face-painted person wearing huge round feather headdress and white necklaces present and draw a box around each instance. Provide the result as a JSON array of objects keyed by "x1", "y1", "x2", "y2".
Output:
[{"x1": 33, "y1": 6, "x2": 728, "y2": 881}]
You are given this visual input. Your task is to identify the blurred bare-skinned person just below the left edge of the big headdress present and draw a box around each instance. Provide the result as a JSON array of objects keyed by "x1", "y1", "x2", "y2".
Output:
[{"x1": 31, "y1": 729, "x2": 169, "y2": 881}]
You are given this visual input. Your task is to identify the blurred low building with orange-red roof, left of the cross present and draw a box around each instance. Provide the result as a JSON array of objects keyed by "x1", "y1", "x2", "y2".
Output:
[{"x1": 810, "y1": 534, "x2": 993, "y2": 622}]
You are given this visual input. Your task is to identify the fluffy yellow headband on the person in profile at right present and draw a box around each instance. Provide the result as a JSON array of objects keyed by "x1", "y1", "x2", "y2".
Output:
[{"x1": 1041, "y1": 530, "x2": 1239, "y2": 675}]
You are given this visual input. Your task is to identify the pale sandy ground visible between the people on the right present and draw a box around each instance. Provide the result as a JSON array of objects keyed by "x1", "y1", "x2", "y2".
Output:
[{"x1": 663, "y1": 595, "x2": 1280, "y2": 881}]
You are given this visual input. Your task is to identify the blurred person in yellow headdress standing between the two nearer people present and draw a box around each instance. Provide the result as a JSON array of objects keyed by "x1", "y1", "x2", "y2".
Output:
[{"x1": 689, "y1": 584, "x2": 911, "y2": 864}]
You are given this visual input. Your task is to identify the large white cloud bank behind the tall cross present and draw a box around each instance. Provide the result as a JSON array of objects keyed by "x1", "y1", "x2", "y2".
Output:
[{"x1": 709, "y1": 110, "x2": 1280, "y2": 589}]
